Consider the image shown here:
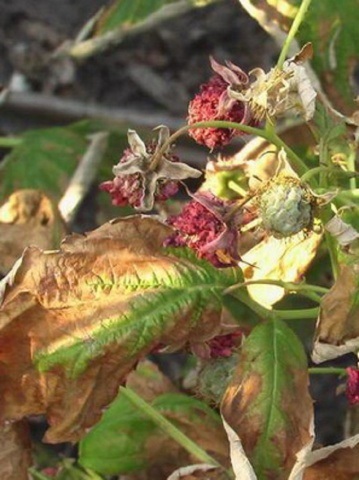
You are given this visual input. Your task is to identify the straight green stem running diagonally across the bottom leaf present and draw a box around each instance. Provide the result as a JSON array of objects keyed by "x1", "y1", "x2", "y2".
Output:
[{"x1": 120, "y1": 387, "x2": 224, "y2": 468}]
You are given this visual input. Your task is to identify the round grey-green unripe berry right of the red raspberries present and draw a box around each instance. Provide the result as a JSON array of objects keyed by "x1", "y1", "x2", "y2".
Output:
[{"x1": 257, "y1": 175, "x2": 314, "y2": 238}]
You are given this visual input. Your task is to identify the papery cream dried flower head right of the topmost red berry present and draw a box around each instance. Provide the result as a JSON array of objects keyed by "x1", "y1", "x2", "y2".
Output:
[{"x1": 229, "y1": 44, "x2": 317, "y2": 121}]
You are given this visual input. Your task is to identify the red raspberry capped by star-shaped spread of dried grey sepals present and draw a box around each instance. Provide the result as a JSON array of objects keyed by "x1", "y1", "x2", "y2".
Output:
[{"x1": 100, "y1": 125, "x2": 202, "y2": 210}]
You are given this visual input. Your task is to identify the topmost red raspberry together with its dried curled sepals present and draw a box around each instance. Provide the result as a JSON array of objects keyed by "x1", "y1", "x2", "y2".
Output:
[{"x1": 188, "y1": 57, "x2": 256, "y2": 150}]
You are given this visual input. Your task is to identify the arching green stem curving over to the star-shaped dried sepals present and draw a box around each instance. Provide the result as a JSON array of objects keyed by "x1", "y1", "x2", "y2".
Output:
[{"x1": 150, "y1": 120, "x2": 308, "y2": 175}]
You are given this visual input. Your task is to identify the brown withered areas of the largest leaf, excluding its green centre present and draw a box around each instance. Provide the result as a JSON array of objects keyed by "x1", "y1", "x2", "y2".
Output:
[{"x1": 0, "y1": 216, "x2": 231, "y2": 443}]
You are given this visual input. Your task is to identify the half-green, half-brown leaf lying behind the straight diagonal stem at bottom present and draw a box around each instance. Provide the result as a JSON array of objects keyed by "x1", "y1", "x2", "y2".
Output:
[{"x1": 79, "y1": 361, "x2": 228, "y2": 478}]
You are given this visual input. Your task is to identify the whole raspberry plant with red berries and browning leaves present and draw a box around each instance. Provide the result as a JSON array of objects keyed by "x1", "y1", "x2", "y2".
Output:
[{"x1": 0, "y1": 0, "x2": 359, "y2": 480}]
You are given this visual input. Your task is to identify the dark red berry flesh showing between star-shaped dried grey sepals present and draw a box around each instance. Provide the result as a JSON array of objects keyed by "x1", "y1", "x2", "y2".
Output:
[{"x1": 100, "y1": 142, "x2": 179, "y2": 208}]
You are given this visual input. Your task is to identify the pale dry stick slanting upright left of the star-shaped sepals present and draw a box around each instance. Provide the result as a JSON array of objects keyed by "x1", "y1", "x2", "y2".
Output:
[{"x1": 59, "y1": 132, "x2": 109, "y2": 223}]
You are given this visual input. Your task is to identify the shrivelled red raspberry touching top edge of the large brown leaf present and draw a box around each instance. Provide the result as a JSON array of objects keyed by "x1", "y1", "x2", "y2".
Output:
[{"x1": 165, "y1": 192, "x2": 239, "y2": 267}]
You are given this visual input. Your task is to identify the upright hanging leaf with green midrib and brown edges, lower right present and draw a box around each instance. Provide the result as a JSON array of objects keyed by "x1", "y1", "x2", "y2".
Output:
[{"x1": 221, "y1": 321, "x2": 313, "y2": 480}]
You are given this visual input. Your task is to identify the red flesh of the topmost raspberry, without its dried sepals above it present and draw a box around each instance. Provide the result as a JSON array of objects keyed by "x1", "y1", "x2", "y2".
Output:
[{"x1": 188, "y1": 75, "x2": 245, "y2": 150}]
